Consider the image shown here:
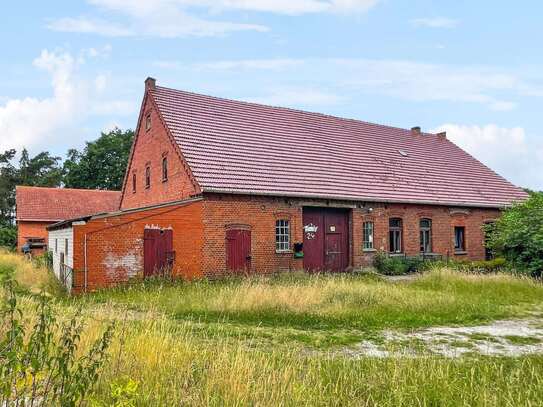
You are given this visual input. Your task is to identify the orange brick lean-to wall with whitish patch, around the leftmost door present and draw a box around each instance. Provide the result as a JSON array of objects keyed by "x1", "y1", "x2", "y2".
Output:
[{"x1": 74, "y1": 201, "x2": 203, "y2": 292}]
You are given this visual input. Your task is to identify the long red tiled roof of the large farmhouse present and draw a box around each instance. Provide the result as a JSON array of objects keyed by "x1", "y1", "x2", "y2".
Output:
[{"x1": 150, "y1": 86, "x2": 527, "y2": 207}]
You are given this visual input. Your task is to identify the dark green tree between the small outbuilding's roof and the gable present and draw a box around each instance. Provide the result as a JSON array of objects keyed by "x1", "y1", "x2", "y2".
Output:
[{"x1": 64, "y1": 128, "x2": 134, "y2": 190}]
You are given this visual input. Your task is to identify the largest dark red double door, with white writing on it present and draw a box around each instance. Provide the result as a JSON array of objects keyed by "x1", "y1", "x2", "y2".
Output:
[{"x1": 303, "y1": 208, "x2": 349, "y2": 271}]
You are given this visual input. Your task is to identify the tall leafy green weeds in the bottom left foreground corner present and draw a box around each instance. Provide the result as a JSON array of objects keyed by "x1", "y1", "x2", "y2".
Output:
[{"x1": 0, "y1": 271, "x2": 113, "y2": 406}]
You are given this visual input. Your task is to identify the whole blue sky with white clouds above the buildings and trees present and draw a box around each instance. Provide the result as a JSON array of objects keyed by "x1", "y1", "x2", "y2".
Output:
[{"x1": 0, "y1": 0, "x2": 543, "y2": 189}]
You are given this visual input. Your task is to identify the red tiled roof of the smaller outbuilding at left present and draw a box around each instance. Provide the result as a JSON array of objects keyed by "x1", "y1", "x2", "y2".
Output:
[{"x1": 16, "y1": 186, "x2": 121, "y2": 221}]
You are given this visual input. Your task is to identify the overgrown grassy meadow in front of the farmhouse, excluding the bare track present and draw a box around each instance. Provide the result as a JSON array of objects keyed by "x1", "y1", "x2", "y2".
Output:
[{"x1": 0, "y1": 253, "x2": 543, "y2": 406}]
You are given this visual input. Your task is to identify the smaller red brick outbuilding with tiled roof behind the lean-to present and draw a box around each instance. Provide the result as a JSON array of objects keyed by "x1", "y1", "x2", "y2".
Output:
[{"x1": 15, "y1": 186, "x2": 121, "y2": 254}]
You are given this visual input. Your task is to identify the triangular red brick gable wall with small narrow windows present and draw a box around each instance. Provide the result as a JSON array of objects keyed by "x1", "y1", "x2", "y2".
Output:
[{"x1": 121, "y1": 98, "x2": 197, "y2": 209}]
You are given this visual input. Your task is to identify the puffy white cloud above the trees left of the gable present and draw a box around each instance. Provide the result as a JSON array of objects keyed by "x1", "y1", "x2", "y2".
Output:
[{"x1": 0, "y1": 50, "x2": 133, "y2": 155}]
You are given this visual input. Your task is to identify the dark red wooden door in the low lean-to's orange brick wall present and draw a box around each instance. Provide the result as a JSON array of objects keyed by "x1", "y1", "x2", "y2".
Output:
[{"x1": 143, "y1": 229, "x2": 173, "y2": 277}]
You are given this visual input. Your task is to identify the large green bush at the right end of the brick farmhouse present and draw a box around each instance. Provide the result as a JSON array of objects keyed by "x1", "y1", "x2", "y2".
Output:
[{"x1": 488, "y1": 192, "x2": 543, "y2": 277}]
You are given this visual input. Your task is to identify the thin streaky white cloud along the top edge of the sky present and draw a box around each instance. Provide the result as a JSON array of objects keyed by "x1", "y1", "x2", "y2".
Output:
[{"x1": 47, "y1": 0, "x2": 380, "y2": 38}]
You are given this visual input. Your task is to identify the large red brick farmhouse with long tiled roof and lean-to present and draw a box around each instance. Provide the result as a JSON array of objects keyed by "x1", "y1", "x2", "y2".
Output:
[{"x1": 45, "y1": 78, "x2": 526, "y2": 290}]
